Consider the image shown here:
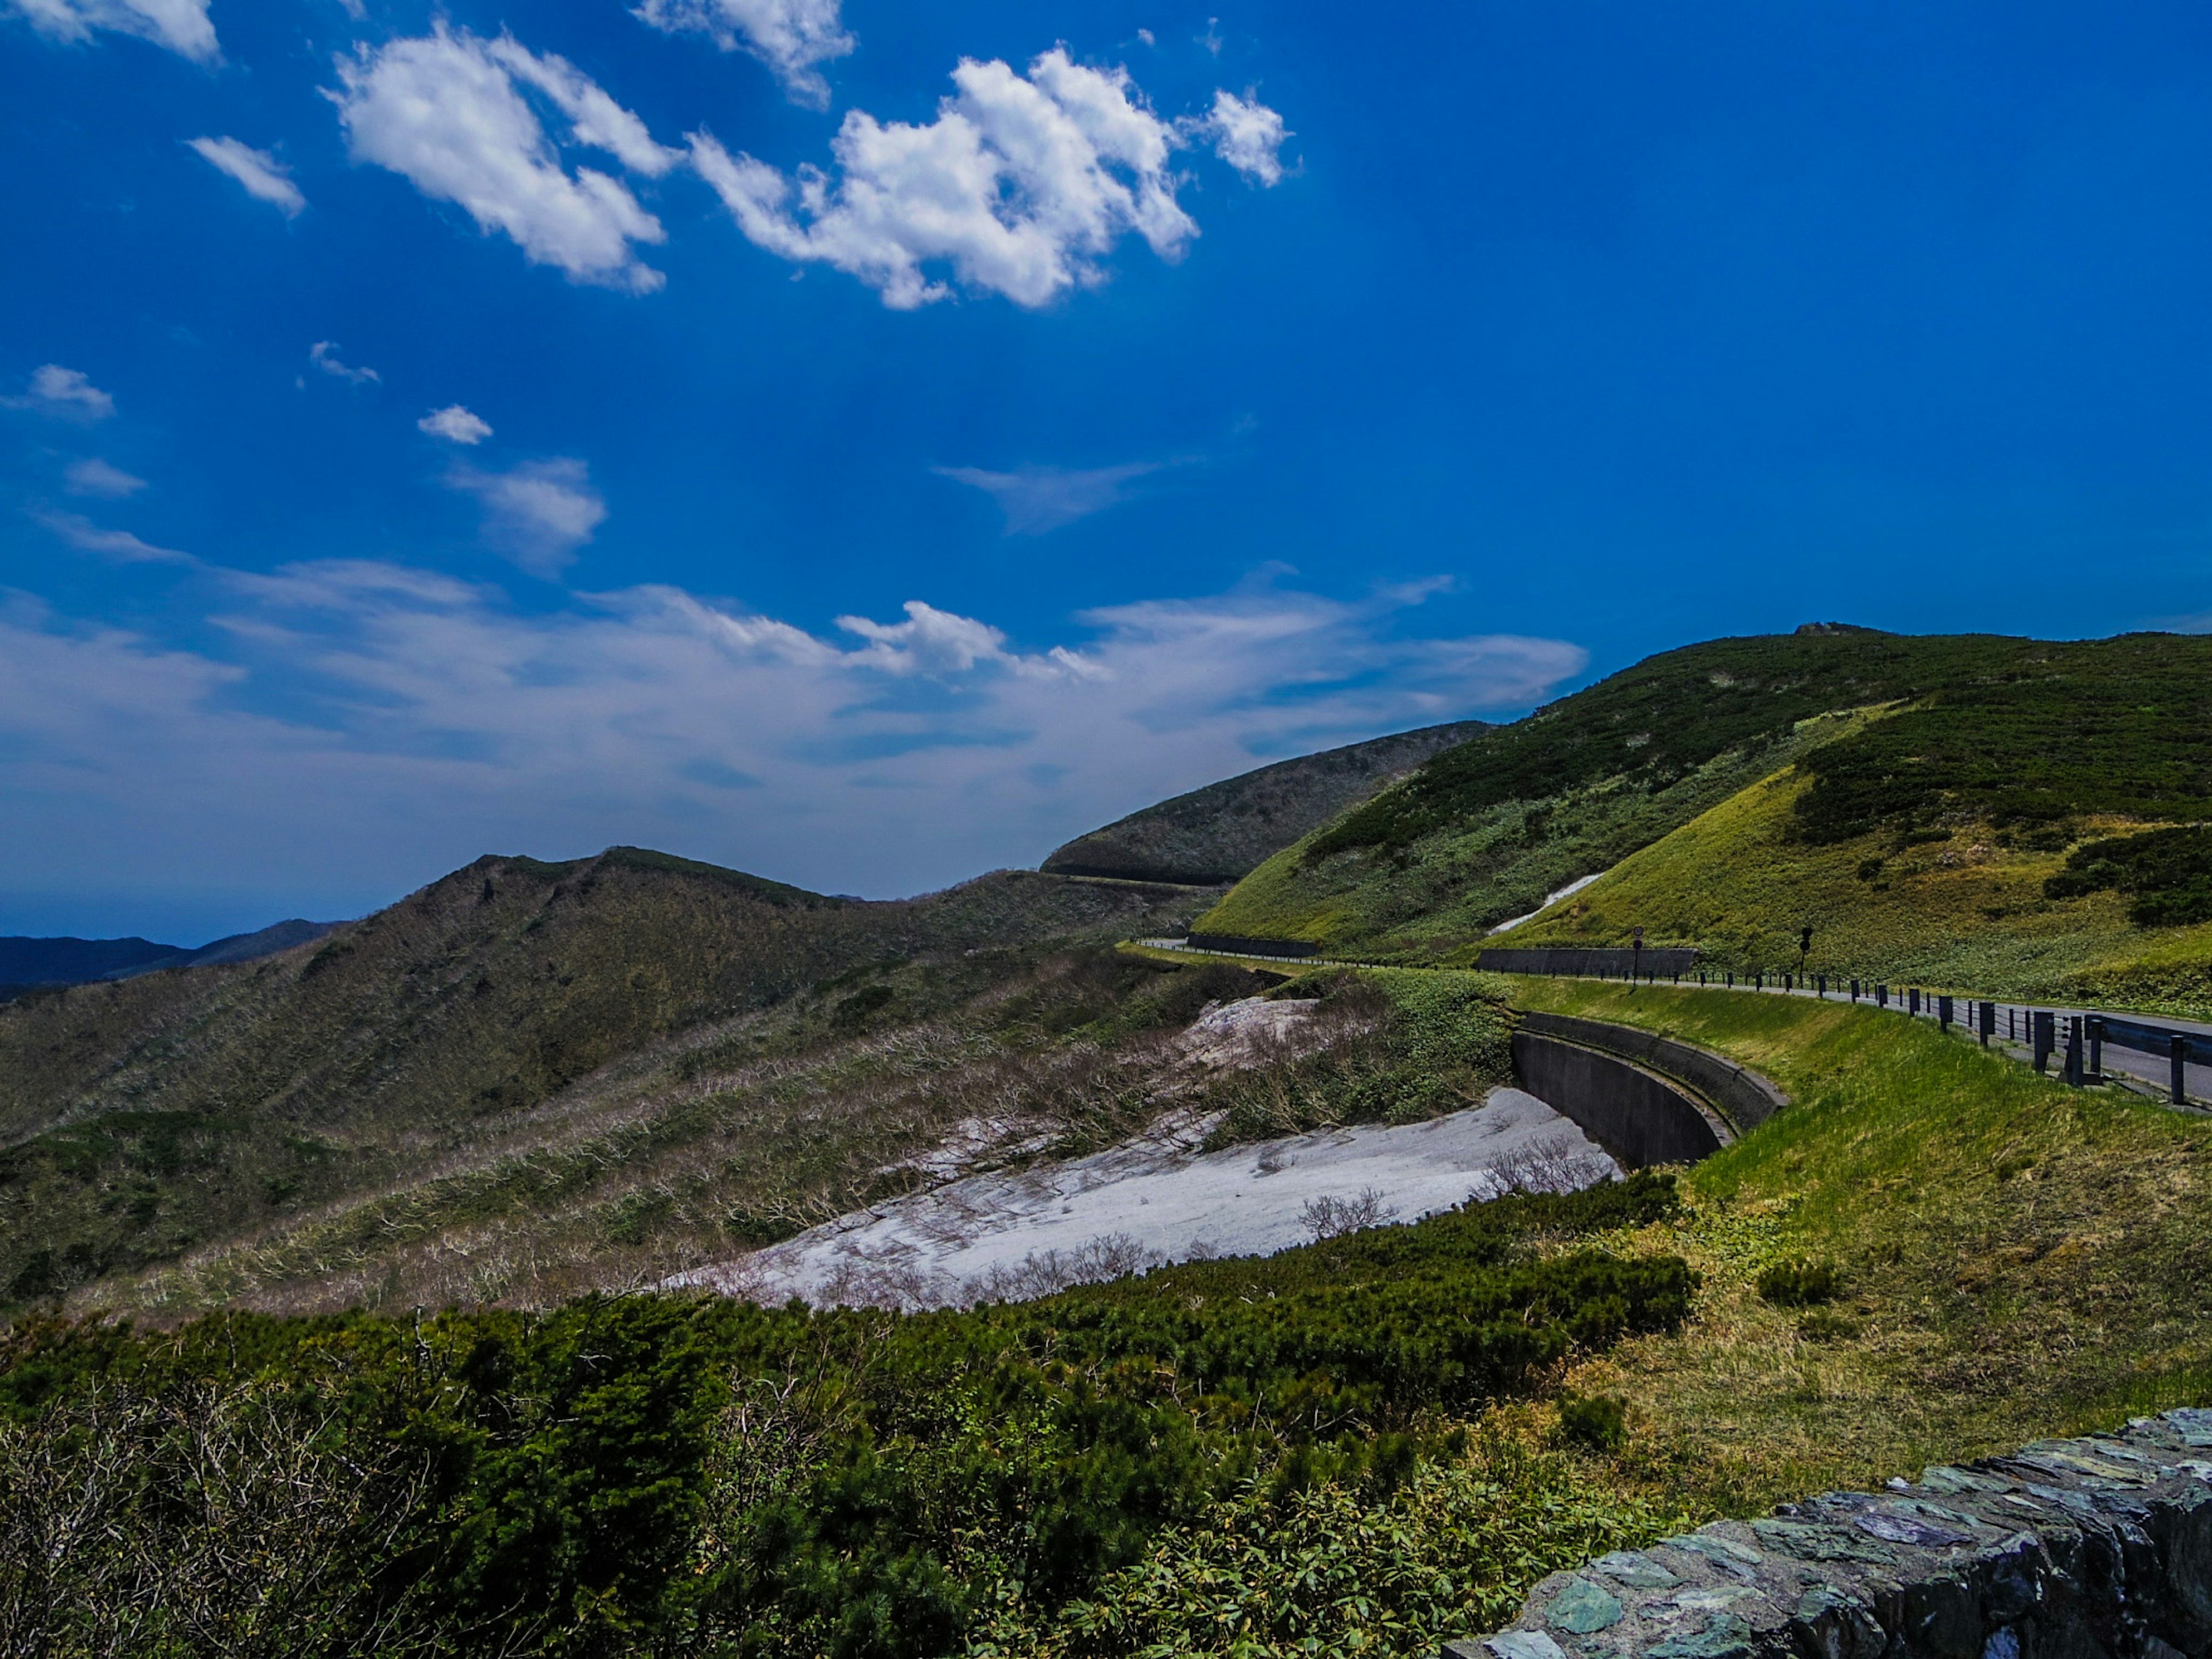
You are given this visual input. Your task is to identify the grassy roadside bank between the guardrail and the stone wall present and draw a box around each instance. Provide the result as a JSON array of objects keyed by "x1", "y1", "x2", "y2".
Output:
[{"x1": 1522, "y1": 980, "x2": 2212, "y2": 1515}]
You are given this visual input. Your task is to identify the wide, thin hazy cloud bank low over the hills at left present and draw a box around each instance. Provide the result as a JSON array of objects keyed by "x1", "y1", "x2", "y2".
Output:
[{"x1": 0, "y1": 562, "x2": 1584, "y2": 914}]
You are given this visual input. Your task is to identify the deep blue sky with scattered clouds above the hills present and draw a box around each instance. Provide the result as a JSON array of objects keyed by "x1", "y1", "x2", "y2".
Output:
[{"x1": 0, "y1": 0, "x2": 2212, "y2": 942}]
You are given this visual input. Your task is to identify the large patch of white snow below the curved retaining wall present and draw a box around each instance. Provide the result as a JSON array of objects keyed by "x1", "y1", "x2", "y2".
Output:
[{"x1": 666, "y1": 1084, "x2": 1622, "y2": 1309}]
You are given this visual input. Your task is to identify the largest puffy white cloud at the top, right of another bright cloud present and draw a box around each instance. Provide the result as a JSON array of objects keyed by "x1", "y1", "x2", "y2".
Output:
[{"x1": 690, "y1": 47, "x2": 1261, "y2": 310}]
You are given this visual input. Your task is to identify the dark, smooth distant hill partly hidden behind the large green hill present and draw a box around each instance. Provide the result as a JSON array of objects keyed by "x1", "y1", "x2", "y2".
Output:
[{"x1": 1044, "y1": 721, "x2": 1488, "y2": 887}]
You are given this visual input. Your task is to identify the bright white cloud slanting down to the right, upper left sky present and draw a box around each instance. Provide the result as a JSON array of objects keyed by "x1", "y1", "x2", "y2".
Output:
[{"x1": 332, "y1": 22, "x2": 681, "y2": 294}]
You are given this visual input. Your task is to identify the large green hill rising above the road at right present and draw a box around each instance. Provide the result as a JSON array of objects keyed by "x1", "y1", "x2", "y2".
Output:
[{"x1": 1201, "y1": 626, "x2": 2212, "y2": 1006}]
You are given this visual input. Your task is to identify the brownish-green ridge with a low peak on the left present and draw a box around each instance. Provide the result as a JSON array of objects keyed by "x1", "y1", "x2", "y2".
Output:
[{"x1": 0, "y1": 850, "x2": 1203, "y2": 1298}]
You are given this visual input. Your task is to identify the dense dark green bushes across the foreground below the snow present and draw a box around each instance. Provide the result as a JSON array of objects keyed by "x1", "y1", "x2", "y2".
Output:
[{"x1": 0, "y1": 1175, "x2": 1692, "y2": 1654}]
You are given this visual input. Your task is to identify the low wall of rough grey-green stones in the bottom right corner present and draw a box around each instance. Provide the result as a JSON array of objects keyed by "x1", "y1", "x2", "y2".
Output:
[{"x1": 1445, "y1": 1409, "x2": 2212, "y2": 1659}]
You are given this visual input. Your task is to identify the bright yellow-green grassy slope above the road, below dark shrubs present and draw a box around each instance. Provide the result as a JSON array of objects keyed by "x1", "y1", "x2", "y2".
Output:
[{"x1": 1500, "y1": 767, "x2": 2212, "y2": 1017}]
